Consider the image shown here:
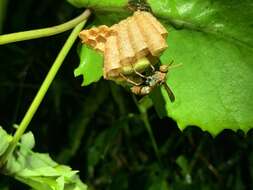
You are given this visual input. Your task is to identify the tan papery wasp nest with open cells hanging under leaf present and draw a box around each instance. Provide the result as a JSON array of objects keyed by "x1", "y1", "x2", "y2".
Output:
[{"x1": 79, "y1": 11, "x2": 168, "y2": 79}]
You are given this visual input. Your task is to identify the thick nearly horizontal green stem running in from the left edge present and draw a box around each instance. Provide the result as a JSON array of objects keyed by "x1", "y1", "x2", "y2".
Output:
[{"x1": 0, "y1": 9, "x2": 91, "y2": 45}]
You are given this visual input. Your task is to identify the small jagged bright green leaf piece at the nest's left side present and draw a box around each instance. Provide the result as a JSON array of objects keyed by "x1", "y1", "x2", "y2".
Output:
[{"x1": 74, "y1": 45, "x2": 103, "y2": 86}]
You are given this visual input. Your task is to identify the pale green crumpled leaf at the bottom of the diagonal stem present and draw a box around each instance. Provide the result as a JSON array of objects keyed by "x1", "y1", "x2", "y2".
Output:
[{"x1": 0, "y1": 127, "x2": 87, "y2": 190}]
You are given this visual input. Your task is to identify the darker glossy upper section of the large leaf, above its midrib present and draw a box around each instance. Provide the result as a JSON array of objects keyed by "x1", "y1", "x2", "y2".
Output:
[{"x1": 148, "y1": 0, "x2": 253, "y2": 48}]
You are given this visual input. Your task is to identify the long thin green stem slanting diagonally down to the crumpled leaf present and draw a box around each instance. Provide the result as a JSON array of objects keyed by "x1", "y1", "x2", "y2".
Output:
[{"x1": 0, "y1": 14, "x2": 89, "y2": 165}]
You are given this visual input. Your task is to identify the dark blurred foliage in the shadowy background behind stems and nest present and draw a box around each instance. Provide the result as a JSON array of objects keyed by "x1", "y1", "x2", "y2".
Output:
[{"x1": 0, "y1": 0, "x2": 253, "y2": 190}]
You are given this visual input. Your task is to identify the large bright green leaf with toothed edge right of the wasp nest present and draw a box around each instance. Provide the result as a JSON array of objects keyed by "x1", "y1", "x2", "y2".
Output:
[{"x1": 152, "y1": 0, "x2": 253, "y2": 134}]
